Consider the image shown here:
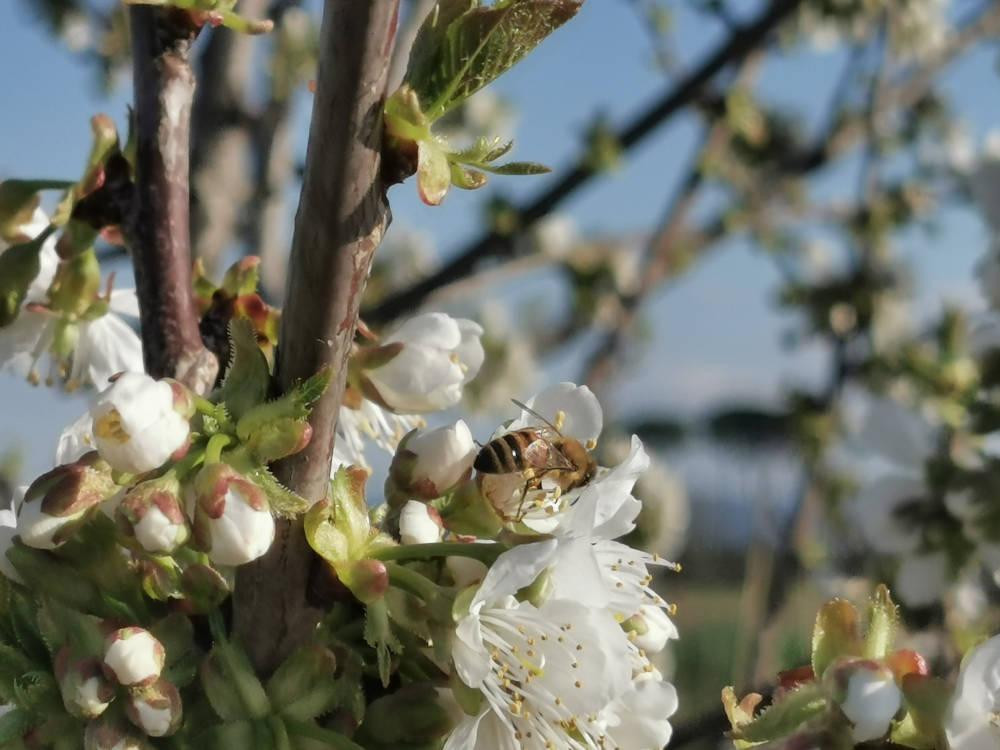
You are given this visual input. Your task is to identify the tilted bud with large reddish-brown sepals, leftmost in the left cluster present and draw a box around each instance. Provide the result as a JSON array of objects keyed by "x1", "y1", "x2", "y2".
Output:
[{"x1": 18, "y1": 452, "x2": 118, "y2": 549}]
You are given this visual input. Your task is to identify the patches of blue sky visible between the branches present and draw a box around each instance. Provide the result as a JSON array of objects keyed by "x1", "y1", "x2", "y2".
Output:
[{"x1": 0, "y1": 0, "x2": 1000, "y2": 482}]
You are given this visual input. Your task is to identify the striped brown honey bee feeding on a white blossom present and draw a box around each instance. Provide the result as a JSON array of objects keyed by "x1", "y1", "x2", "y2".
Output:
[{"x1": 472, "y1": 401, "x2": 597, "y2": 520}]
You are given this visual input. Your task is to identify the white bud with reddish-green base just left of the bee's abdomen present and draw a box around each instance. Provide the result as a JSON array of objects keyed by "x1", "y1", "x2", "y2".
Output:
[{"x1": 405, "y1": 419, "x2": 478, "y2": 499}]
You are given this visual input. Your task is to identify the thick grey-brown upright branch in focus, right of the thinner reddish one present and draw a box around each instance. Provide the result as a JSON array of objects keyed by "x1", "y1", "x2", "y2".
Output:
[{"x1": 234, "y1": 0, "x2": 398, "y2": 674}]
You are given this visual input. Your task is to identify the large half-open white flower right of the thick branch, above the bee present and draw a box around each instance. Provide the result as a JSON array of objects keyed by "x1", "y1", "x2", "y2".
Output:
[{"x1": 365, "y1": 313, "x2": 485, "y2": 414}]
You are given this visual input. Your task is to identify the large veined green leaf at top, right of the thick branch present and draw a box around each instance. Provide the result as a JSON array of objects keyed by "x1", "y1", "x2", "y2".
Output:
[{"x1": 406, "y1": 0, "x2": 582, "y2": 122}]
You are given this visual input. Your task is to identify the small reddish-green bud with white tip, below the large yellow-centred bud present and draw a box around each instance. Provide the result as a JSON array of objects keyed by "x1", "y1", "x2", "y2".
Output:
[{"x1": 116, "y1": 474, "x2": 191, "y2": 555}]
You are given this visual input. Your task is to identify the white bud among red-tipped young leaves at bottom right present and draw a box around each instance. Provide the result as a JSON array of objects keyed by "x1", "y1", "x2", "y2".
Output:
[{"x1": 824, "y1": 659, "x2": 902, "y2": 742}]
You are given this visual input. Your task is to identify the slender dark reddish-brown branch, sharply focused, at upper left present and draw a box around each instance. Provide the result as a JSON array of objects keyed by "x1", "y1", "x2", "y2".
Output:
[{"x1": 128, "y1": 6, "x2": 218, "y2": 392}]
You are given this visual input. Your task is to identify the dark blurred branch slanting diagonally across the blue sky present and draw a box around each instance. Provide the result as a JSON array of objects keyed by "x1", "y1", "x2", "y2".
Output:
[{"x1": 364, "y1": 0, "x2": 802, "y2": 323}]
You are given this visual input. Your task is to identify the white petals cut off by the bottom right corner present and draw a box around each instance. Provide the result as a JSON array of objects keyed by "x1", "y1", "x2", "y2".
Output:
[{"x1": 945, "y1": 636, "x2": 1000, "y2": 750}]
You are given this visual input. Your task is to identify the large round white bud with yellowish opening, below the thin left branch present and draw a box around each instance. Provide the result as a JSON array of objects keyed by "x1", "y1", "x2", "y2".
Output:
[{"x1": 90, "y1": 372, "x2": 190, "y2": 474}]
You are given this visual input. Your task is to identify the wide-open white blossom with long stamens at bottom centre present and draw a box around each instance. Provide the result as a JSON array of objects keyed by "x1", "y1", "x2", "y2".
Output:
[{"x1": 445, "y1": 542, "x2": 632, "y2": 750}]
